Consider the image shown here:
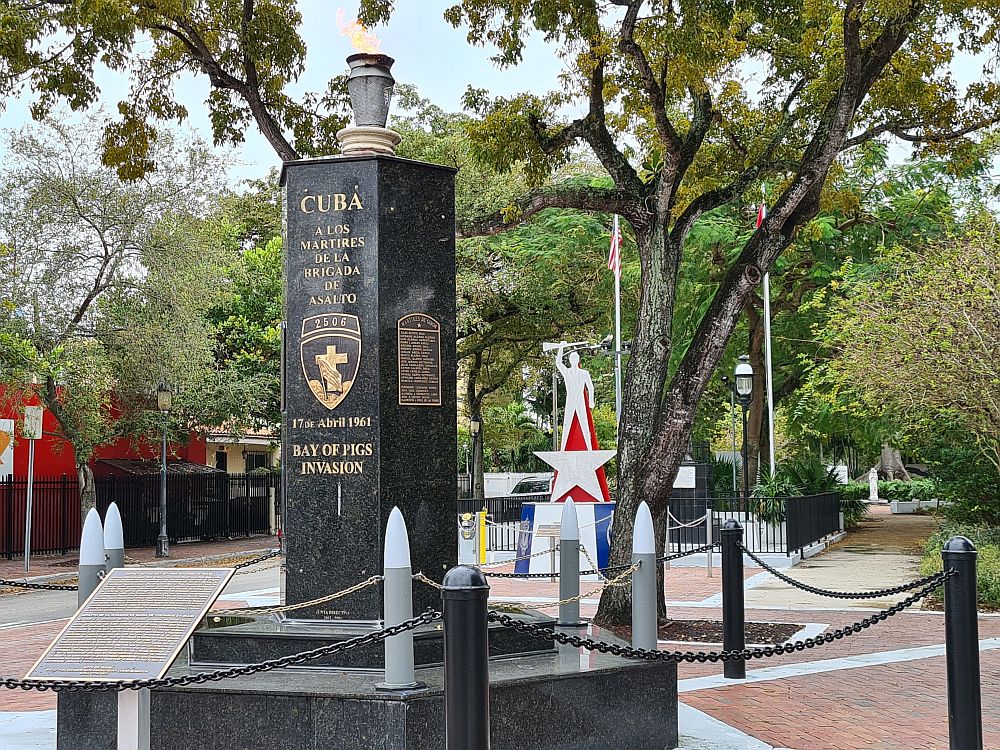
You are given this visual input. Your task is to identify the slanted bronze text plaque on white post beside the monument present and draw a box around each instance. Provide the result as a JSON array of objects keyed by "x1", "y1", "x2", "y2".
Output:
[{"x1": 25, "y1": 568, "x2": 234, "y2": 680}]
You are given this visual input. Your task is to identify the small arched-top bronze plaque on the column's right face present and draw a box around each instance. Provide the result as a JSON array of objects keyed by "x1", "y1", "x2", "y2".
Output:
[{"x1": 396, "y1": 313, "x2": 441, "y2": 406}]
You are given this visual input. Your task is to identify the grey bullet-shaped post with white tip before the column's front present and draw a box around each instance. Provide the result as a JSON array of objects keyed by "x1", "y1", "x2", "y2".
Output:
[{"x1": 375, "y1": 508, "x2": 424, "y2": 690}]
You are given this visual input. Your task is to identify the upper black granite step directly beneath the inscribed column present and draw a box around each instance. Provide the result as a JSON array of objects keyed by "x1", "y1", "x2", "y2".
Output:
[{"x1": 189, "y1": 612, "x2": 555, "y2": 671}]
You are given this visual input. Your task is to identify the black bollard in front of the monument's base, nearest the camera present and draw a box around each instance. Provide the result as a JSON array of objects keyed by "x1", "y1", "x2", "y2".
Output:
[{"x1": 441, "y1": 565, "x2": 490, "y2": 750}]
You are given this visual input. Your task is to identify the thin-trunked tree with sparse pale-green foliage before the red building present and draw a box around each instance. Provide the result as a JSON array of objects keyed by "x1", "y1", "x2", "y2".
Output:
[{"x1": 0, "y1": 117, "x2": 255, "y2": 512}]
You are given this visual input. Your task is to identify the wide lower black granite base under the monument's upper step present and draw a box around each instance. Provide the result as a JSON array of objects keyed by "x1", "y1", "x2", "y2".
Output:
[{"x1": 58, "y1": 633, "x2": 677, "y2": 750}]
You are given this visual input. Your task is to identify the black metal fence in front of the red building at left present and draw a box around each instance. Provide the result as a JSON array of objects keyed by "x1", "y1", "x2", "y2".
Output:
[{"x1": 0, "y1": 472, "x2": 281, "y2": 559}]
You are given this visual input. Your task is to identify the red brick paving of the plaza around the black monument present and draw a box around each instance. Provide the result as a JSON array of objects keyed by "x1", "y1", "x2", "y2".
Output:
[{"x1": 0, "y1": 516, "x2": 1000, "y2": 750}]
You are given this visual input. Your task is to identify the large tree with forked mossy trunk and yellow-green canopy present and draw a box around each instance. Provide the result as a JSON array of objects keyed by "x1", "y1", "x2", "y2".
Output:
[{"x1": 362, "y1": 0, "x2": 1000, "y2": 620}]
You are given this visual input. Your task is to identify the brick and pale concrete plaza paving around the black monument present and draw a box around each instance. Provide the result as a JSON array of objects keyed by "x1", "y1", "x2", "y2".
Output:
[{"x1": 0, "y1": 513, "x2": 1000, "y2": 750}]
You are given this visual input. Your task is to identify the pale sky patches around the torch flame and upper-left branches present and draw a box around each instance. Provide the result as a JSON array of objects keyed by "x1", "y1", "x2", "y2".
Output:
[{"x1": 0, "y1": 0, "x2": 562, "y2": 185}]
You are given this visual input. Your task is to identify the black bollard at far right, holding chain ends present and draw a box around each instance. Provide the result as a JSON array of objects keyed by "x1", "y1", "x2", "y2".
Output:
[{"x1": 941, "y1": 536, "x2": 983, "y2": 750}]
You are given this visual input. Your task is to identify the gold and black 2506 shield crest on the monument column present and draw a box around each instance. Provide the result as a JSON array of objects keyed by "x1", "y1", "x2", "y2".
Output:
[{"x1": 299, "y1": 313, "x2": 361, "y2": 409}]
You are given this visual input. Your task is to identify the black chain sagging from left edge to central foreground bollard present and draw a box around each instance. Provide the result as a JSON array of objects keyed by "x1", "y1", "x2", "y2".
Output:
[{"x1": 0, "y1": 610, "x2": 441, "y2": 693}]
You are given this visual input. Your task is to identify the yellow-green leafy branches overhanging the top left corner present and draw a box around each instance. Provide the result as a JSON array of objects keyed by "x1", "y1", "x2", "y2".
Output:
[{"x1": 0, "y1": 0, "x2": 347, "y2": 179}]
